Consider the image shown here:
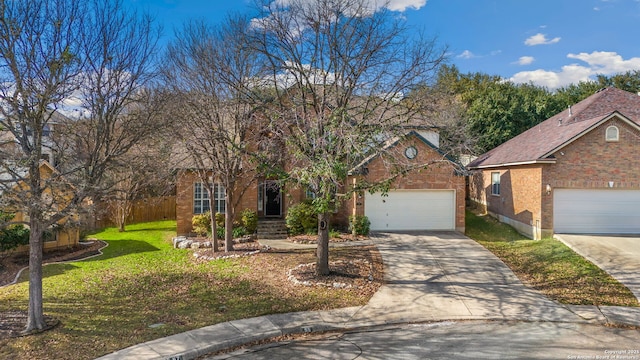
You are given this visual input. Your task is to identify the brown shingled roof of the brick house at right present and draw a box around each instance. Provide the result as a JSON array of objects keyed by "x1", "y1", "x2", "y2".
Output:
[{"x1": 468, "y1": 87, "x2": 640, "y2": 169}]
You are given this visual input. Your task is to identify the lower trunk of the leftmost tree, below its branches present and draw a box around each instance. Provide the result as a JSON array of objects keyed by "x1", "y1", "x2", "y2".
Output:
[{"x1": 24, "y1": 216, "x2": 47, "y2": 333}]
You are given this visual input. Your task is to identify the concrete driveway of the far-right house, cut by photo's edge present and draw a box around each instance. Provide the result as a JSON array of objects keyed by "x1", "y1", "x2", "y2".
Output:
[{"x1": 555, "y1": 234, "x2": 640, "y2": 300}]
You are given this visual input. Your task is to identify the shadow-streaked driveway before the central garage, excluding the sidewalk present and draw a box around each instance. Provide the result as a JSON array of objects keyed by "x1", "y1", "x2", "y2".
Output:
[{"x1": 353, "y1": 232, "x2": 575, "y2": 322}]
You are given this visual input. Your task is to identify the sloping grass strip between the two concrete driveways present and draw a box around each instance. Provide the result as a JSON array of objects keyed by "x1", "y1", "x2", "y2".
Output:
[{"x1": 466, "y1": 211, "x2": 638, "y2": 306}]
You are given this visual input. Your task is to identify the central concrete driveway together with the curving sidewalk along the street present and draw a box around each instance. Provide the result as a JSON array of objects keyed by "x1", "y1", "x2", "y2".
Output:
[{"x1": 100, "y1": 232, "x2": 640, "y2": 359}]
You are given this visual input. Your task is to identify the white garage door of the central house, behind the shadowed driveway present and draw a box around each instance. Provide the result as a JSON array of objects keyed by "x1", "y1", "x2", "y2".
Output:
[{"x1": 364, "y1": 190, "x2": 455, "y2": 231}]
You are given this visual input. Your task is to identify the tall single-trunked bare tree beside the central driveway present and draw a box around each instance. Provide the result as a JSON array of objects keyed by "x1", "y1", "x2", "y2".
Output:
[{"x1": 249, "y1": 0, "x2": 445, "y2": 275}]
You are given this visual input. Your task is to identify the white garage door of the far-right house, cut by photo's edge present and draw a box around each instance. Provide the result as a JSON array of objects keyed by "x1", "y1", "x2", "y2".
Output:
[{"x1": 553, "y1": 189, "x2": 640, "y2": 234}]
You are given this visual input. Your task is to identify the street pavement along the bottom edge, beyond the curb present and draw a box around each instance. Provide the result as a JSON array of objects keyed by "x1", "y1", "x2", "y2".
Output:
[{"x1": 206, "y1": 321, "x2": 640, "y2": 360}]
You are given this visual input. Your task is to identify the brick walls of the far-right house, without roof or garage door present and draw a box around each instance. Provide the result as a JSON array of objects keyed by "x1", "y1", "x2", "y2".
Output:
[{"x1": 470, "y1": 117, "x2": 640, "y2": 238}]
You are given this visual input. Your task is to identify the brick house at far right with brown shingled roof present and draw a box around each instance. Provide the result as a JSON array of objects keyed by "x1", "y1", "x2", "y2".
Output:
[{"x1": 468, "y1": 88, "x2": 640, "y2": 239}]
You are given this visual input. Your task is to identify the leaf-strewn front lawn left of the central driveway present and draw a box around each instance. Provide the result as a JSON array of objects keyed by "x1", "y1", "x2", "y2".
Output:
[{"x1": 0, "y1": 221, "x2": 381, "y2": 359}]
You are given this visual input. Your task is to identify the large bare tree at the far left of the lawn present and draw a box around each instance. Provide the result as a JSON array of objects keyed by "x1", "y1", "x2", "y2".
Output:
[{"x1": 0, "y1": 0, "x2": 158, "y2": 332}]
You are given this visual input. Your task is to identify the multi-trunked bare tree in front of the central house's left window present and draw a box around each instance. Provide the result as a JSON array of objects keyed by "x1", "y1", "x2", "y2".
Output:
[{"x1": 163, "y1": 17, "x2": 263, "y2": 251}]
